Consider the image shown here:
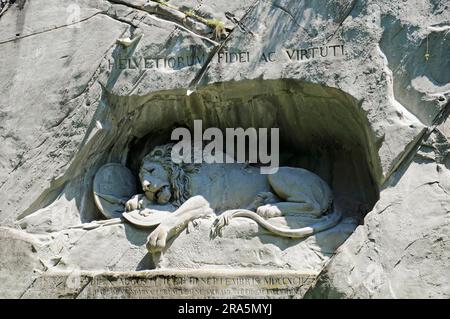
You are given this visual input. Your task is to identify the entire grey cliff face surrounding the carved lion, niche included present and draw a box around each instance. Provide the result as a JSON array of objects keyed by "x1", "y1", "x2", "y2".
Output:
[{"x1": 0, "y1": 0, "x2": 450, "y2": 298}]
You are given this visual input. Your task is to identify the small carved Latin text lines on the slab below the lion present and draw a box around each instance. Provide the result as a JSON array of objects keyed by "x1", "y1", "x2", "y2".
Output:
[{"x1": 86, "y1": 275, "x2": 314, "y2": 298}]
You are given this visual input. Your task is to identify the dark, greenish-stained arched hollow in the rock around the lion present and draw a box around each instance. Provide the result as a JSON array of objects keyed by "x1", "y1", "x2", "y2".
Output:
[{"x1": 22, "y1": 79, "x2": 381, "y2": 228}]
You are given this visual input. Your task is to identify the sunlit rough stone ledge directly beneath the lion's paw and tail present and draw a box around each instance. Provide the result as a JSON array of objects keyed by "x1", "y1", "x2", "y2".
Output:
[{"x1": 153, "y1": 217, "x2": 356, "y2": 273}]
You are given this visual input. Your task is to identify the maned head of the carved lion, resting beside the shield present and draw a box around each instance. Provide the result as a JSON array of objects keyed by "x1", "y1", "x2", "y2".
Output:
[{"x1": 139, "y1": 144, "x2": 198, "y2": 207}]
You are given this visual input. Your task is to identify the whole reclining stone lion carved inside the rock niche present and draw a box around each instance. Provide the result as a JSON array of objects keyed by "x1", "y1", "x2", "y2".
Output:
[{"x1": 123, "y1": 144, "x2": 341, "y2": 252}]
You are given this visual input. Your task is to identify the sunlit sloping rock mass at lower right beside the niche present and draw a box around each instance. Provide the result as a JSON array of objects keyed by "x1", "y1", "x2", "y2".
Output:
[{"x1": 308, "y1": 133, "x2": 450, "y2": 299}]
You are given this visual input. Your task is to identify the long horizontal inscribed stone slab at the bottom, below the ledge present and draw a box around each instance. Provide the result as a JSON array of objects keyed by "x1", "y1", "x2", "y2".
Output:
[{"x1": 23, "y1": 270, "x2": 317, "y2": 299}]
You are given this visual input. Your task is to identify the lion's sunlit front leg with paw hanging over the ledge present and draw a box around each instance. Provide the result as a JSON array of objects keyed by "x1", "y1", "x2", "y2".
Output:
[{"x1": 147, "y1": 196, "x2": 214, "y2": 253}]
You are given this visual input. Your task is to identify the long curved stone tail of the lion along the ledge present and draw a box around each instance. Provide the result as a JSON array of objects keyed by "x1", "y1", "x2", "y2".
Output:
[{"x1": 223, "y1": 209, "x2": 342, "y2": 238}]
